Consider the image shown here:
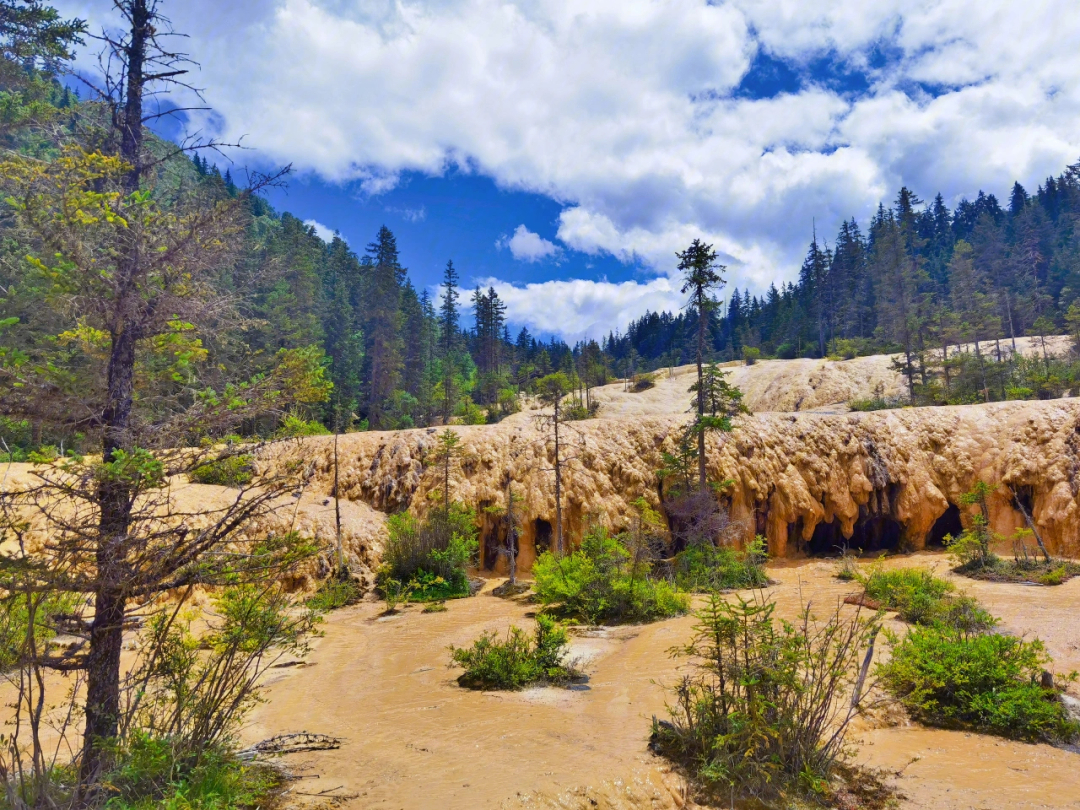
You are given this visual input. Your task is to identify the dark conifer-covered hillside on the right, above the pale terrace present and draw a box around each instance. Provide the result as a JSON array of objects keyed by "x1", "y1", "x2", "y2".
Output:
[{"x1": 604, "y1": 170, "x2": 1080, "y2": 404}]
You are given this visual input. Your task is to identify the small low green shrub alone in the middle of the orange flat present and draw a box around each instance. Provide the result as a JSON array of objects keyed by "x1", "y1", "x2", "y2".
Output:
[{"x1": 450, "y1": 613, "x2": 578, "y2": 689}]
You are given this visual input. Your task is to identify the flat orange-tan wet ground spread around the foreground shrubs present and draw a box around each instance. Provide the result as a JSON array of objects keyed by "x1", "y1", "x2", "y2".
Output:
[{"x1": 245, "y1": 554, "x2": 1080, "y2": 810}]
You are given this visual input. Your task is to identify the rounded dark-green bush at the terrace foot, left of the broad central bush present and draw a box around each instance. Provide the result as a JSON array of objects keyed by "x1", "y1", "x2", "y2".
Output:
[{"x1": 376, "y1": 503, "x2": 480, "y2": 602}]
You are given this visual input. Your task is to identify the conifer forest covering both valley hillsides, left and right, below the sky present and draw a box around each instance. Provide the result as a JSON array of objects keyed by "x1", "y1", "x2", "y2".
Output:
[{"x1": 6, "y1": 42, "x2": 1080, "y2": 450}]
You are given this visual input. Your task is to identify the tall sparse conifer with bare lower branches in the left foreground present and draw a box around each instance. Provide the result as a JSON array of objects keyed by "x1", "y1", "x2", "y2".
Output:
[{"x1": 0, "y1": 0, "x2": 325, "y2": 794}]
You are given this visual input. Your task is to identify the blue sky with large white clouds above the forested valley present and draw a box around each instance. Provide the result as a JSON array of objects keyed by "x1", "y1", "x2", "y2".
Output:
[{"x1": 56, "y1": 0, "x2": 1080, "y2": 339}]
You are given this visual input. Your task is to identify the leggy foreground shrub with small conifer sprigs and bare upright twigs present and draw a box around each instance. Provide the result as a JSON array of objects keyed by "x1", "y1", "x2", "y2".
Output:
[{"x1": 651, "y1": 593, "x2": 879, "y2": 801}]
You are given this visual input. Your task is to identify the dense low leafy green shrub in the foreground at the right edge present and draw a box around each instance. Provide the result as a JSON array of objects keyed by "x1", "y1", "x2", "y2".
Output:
[{"x1": 878, "y1": 623, "x2": 1080, "y2": 741}]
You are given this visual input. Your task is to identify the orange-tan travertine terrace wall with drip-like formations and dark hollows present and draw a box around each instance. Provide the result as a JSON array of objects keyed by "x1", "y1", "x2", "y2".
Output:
[{"x1": 276, "y1": 341, "x2": 1080, "y2": 570}]
